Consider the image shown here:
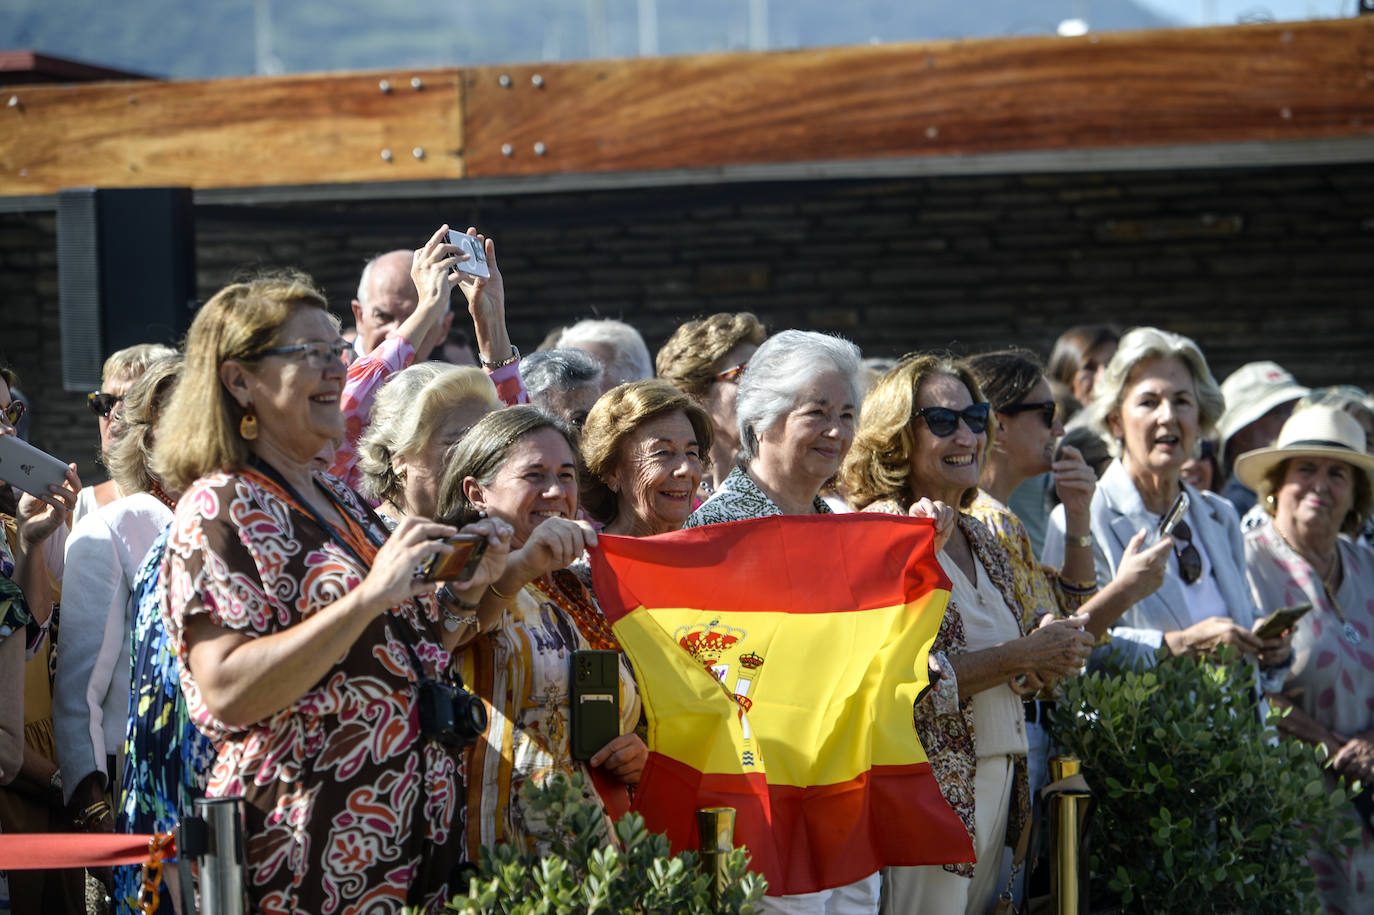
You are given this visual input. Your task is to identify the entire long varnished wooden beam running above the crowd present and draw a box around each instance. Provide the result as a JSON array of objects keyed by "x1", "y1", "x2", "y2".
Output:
[{"x1": 0, "y1": 16, "x2": 1374, "y2": 196}]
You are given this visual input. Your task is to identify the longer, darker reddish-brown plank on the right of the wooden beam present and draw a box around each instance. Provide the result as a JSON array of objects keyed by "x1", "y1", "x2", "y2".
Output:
[{"x1": 463, "y1": 16, "x2": 1374, "y2": 177}]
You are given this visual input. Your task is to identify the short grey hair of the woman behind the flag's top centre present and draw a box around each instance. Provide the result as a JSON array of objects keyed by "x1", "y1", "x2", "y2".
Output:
[{"x1": 735, "y1": 330, "x2": 863, "y2": 464}]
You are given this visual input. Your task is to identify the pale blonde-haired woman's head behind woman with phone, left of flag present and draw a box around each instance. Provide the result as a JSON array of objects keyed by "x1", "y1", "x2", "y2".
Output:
[{"x1": 357, "y1": 363, "x2": 503, "y2": 530}]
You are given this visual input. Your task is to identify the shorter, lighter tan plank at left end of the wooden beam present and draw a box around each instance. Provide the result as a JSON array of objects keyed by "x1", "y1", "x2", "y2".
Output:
[{"x1": 0, "y1": 70, "x2": 464, "y2": 195}]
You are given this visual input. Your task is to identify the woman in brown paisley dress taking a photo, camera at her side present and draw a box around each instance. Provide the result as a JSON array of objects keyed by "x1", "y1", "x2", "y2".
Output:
[{"x1": 153, "y1": 270, "x2": 510, "y2": 914}]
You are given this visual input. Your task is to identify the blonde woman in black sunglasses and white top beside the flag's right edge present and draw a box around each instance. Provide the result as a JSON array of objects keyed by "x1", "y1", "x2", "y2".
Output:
[{"x1": 841, "y1": 356, "x2": 1094, "y2": 912}]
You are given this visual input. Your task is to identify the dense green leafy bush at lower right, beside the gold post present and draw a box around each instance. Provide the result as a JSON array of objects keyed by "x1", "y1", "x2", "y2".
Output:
[{"x1": 1048, "y1": 645, "x2": 1359, "y2": 915}]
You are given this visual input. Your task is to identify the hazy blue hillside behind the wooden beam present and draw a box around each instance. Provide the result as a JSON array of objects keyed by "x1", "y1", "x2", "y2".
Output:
[{"x1": 0, "y1": 0, "x2": 1172, "y2": 78}]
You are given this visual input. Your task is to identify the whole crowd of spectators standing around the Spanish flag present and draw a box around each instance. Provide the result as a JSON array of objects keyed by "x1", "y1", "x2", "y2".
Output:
[{"x1": 0, "y1": 227, "x2": 1374, "y2": 914}]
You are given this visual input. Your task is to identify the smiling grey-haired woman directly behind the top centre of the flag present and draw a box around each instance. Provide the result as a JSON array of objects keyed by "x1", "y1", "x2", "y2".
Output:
[{"x1": 686, "y1": 330, "x2": 881, "y2": 912}]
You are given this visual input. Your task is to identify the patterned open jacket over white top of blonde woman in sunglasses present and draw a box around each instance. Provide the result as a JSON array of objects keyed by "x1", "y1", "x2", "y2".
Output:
[{"x1": 864, "y1": 500, "x2": 1031, "y2": 878}]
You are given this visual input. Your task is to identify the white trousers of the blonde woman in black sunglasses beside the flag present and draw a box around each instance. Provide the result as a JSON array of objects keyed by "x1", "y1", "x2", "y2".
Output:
[{"x1": 882, "y1": 756, "x2": 1013, "y2": 915}]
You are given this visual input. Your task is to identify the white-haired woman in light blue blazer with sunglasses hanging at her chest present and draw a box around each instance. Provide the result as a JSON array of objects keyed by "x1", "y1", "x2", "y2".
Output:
[{"x1": 1043, "y1": 327, "x2": 1289, "y2": 670}]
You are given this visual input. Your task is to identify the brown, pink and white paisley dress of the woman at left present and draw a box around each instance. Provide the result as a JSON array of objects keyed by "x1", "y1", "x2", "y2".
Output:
[{"x1": 159, "y1": 470, "x2": 464, "y2": 915}]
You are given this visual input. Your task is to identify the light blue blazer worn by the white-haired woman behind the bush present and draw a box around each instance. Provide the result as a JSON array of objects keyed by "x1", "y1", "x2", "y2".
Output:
[{"x1": 1041, "y1": 460, "x2": 1268, "y2": 670}]
